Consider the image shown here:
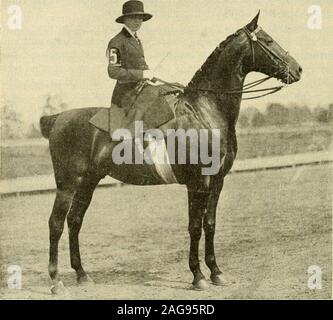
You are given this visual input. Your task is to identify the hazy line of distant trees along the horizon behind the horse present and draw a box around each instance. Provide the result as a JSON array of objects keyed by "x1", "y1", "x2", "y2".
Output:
[{"x1": 1, "y1": 95, "x2": 333, "y2": 140}]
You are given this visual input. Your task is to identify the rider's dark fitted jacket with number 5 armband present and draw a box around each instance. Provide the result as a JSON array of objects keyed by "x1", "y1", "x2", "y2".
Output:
[{"x1": 107, "y1": 28, "x2": 148, "y2": 107}]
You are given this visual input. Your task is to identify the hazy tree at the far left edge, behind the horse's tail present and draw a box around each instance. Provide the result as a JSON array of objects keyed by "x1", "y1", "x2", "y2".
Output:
[{"x1": 1, "y1": 103, "x2": 23, "y2": 139}]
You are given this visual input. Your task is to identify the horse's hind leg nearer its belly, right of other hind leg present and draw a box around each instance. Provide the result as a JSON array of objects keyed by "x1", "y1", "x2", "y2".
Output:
[{"x1": 67, "y1": 177, "x2": 99, "y2": 284}]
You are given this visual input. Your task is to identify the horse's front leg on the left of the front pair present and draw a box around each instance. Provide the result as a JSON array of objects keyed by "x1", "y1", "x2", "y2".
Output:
[{"x1": 188, "y1": 191, "x2": 208, "y2": 290}]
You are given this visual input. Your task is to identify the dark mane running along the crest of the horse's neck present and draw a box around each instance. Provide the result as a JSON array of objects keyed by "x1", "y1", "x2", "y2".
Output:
[{"x1": 187, "y1": 32, "x2": 237, "y2": 88}]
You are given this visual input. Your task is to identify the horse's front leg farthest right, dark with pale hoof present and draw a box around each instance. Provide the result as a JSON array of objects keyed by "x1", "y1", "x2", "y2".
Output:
[{"x1": 204, "y1": 182, "x2": 225, "y2": 285}]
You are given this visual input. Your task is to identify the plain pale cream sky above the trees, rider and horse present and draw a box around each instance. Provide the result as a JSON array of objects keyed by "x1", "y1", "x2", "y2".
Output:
[{"x1": 0, "y1": 0, "x2": 333, "y2": 122}]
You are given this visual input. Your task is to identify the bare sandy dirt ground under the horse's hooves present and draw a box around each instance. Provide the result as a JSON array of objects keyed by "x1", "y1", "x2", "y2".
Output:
[{"x1": 0, "y1": 165, "x2": 332, "y2": 299}]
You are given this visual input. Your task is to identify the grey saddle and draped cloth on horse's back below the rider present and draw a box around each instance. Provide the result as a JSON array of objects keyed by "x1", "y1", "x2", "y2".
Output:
[{"x1": 89, "y1": 82, "x2": 182, "y2": 138}]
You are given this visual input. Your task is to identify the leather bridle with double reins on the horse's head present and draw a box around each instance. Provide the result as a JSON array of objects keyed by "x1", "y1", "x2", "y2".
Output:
[{"x1": 183, "y1": 26, "x2": 289, "y2": 100}]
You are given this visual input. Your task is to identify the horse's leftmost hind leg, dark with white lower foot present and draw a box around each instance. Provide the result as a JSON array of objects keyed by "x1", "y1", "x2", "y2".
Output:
[{"x1": 49, "y1": 188, "x2": 74, "y2": 293}]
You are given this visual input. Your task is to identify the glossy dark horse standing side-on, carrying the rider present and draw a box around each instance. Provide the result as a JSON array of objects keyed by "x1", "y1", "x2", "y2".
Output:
[{"x1": 40, "y1": 11, "x2": 302, "y2": 294}]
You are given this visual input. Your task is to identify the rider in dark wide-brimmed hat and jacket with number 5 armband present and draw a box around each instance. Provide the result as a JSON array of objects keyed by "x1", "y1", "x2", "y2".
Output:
[{"x1": 107, "y1": 0, "x2": 153, "y2": 108}]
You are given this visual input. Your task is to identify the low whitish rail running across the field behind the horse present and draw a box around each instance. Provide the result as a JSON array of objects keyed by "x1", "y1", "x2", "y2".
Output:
[{"x1": 0, "y1": 151, "x2": 333, "y2": 198}]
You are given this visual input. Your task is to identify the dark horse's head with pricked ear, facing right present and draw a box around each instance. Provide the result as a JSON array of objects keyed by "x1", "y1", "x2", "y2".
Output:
[{"x1": 239, "y1": 12, "x2": 302, "y2": 84}]
